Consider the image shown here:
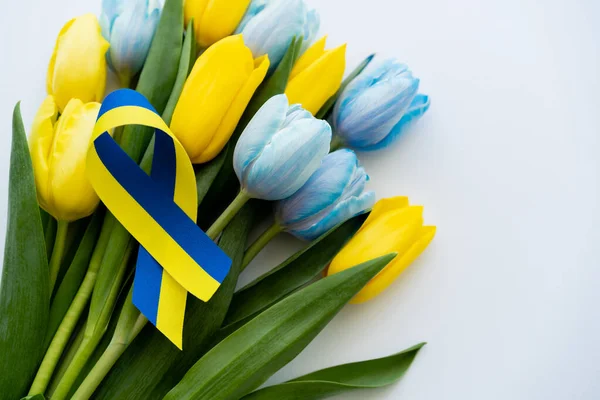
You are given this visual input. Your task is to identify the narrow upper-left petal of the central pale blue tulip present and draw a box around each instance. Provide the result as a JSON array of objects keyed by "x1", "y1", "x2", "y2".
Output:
[{"x1": 233, "y1": 94, "x2": 288, "y2": 182}]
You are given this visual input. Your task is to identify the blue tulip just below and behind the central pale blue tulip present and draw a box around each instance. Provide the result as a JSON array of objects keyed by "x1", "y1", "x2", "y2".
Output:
[{"x1": 275, "y1": 149, "x2": 375, "y2": 240}]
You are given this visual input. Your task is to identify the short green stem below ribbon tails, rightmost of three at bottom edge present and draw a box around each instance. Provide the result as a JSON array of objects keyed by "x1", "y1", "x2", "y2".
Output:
[{"x1": 71, "y1": 312, "x2": 148, "y2": 400}]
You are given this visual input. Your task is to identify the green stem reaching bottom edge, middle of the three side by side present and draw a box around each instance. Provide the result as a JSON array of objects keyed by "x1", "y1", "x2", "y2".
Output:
[{"x1": 52, "y1": 240, "x2": 135, "y2": 400}]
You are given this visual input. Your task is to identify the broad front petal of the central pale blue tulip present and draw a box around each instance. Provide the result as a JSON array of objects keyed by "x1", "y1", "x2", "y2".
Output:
[{"x1": 243, "y1": 119, "x2": 331, "y2": 200}]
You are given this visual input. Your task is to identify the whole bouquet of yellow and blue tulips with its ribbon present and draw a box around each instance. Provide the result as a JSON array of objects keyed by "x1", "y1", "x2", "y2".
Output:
[{"x1": 0, "y1": 0, "x2": 435, "y2": 400}]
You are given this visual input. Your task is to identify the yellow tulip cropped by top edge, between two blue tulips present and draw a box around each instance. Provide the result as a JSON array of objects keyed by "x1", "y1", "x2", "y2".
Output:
[{"x1": 183, "y1": 0, "x2": 250, "y2": 48}]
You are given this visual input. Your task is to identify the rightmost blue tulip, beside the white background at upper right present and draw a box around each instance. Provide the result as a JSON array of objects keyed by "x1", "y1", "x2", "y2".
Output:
[{"x1": 333, "y1": 60, "x2": 429, "y2": 151}]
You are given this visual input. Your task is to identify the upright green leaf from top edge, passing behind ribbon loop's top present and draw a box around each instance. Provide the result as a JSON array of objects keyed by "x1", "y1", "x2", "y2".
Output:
[{"x1": 120, "y1": 0, "x2": 183, "y2": 163}]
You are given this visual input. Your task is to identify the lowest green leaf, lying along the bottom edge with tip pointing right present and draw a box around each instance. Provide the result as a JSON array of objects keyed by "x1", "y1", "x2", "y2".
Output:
[{"x1": 242, "y1": 343, "x2": 425, "y2": 400}]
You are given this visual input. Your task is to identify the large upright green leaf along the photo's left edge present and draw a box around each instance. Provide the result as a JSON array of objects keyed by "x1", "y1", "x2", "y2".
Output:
[{"x1": 0, "y1": 104, "x2": 50, "y2": 399}]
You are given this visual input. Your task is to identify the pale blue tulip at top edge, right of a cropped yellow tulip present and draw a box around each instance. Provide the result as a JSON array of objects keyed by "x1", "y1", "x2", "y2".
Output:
[{"x1": 236, "y1": 0, "x2": 320, "y2": 70}]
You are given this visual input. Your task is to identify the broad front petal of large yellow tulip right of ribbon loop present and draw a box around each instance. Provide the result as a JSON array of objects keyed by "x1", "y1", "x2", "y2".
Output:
[{"x1": 171, "y1": 35, "x2": 255, "y2": 161}]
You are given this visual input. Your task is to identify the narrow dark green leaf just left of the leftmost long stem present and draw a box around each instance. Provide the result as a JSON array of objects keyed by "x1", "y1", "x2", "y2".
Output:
[{"x1": 45, "y1": 209, "x2": 104, "y2": 348}]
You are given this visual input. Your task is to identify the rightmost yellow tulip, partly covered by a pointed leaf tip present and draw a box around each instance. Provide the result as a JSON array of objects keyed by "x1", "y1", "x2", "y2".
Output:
[{"x1": 327, "y1": 197, "x2": 436, "y2": 303}]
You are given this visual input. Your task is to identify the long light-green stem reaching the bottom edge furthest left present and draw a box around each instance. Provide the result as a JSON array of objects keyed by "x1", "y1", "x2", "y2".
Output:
[{"x1": 29, "y1": 214, "x2": 113, "y2": 395}]
